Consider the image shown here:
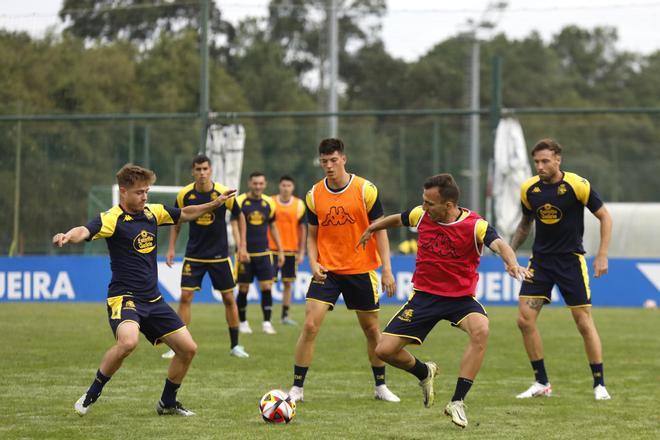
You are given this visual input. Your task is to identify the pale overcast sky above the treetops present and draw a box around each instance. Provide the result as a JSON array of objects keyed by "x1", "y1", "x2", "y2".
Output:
[{"x1": 0, "y1": 0, "x2": 660, "y2": 61}]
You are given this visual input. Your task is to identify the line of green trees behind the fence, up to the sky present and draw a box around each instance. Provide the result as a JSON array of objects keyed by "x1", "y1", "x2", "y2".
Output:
[{"x1": 0, "y1": 0, "x2": 660, "y2": 253}]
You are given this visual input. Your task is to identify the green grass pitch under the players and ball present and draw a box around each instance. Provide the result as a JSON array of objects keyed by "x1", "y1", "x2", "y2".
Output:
[{"x1": 0, "y1": 303, "x2": 660, "y2": 440}]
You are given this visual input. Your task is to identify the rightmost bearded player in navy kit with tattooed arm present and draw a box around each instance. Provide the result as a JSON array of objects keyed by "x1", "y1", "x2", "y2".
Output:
[{"x1": 511, "y1": 139, "x2": 612, "y2": 400}]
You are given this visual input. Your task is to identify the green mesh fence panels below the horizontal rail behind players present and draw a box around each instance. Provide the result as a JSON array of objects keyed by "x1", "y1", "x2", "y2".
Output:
[{"x1": 0, "y1": 113, "x2": 660, "y2": 255}]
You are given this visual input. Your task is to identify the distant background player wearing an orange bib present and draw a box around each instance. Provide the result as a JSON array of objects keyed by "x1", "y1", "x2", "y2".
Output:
[{"x1": 268, "y1": 175, "x2": 307, "y2": 325}]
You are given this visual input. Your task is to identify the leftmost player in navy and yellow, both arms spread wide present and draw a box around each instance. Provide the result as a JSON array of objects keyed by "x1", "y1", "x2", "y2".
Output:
[{"x1": 53, "y1": 164, "x2": 236, "y2": 416}]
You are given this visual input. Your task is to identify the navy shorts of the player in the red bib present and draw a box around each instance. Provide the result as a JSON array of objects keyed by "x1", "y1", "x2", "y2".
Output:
[{"x1": 383, "y1": 290, "x2": 488, "y2": 344}]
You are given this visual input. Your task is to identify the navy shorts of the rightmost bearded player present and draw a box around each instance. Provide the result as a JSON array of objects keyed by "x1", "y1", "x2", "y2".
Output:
[{"x1": 519, "y1": 254, "x2": 591, "y2": 307}]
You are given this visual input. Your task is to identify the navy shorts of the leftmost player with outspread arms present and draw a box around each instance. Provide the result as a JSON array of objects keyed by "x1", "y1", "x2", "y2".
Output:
[{"x1": 107, "y1": 295, "x2": 186, "y2": 345}]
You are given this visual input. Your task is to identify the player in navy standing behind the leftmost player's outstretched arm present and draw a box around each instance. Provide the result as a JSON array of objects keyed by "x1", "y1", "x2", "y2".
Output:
[{"x1": 163, "y1": 154, "x2": 249, "y2": 359}]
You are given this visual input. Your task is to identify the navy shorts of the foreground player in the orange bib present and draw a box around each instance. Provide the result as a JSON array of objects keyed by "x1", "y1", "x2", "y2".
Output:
[{"x1": 306, "y1": 270, "x2": 380, "y2": 312}]
